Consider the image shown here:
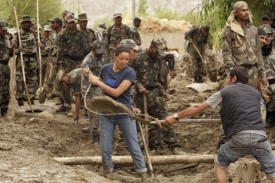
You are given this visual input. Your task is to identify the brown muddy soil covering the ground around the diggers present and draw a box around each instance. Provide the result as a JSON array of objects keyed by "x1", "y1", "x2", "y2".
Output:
[{"x1": 0, "y1": 53, "x2": 274, "y2": 183}]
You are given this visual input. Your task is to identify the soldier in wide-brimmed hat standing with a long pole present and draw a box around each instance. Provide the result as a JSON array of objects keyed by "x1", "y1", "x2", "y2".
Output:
[{"x1": 15, "y1": 15, "x2": 41, "y2": 106}]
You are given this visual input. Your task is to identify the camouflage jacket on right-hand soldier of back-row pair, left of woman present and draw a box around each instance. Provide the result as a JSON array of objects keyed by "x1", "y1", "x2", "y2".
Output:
[{"x1": 80, "y1": 28, "x2": 96, "y2": 57}]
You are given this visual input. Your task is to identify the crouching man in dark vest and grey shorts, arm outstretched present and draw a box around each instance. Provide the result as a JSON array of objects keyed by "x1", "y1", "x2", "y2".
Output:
[{"x1": 164, "y1": 66, "x2": 275, "y2": 183}]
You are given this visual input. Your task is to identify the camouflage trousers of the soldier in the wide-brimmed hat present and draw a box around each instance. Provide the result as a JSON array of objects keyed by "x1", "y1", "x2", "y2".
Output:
[{"x1": 16, "y1": 56, "x2": 38, "y2": 100}]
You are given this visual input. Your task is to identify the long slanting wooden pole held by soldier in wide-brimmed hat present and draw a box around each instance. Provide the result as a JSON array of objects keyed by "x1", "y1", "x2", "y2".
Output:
[{"x1": 13, "y1": 6, "x2": 33, "y2": 112}]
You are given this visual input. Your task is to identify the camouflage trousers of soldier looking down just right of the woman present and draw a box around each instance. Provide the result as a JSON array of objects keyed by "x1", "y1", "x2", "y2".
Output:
[{"x1": 134, "y1": 90, "x2": 180, "y2": 150}]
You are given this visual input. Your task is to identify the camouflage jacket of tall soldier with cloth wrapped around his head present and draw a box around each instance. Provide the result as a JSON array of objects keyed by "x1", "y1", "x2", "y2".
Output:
[{"x1": 222, "y1": 25, "x2": 265, "y2": 78}]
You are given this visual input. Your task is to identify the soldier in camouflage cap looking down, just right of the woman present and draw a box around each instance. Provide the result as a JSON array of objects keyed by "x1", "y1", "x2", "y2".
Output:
[{"x1": 132, "y1": 37, "x2": 183, "y2": 154}]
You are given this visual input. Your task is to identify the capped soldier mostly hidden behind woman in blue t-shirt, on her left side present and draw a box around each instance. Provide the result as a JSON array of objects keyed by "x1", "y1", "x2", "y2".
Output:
[{"x1": 81, "y1": 40, "x2": 107, "y2": 142}]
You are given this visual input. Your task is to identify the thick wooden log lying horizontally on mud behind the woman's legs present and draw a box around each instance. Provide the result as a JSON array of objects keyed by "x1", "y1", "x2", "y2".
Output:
[{"x1": 54, "y1": 154, "x2": 215, "y2": 165}]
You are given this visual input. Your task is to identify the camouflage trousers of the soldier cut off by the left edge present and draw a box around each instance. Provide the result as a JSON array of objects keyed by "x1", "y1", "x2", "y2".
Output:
[{"x1": 0, "y1": 62, "x2": 10, "y2": 111}]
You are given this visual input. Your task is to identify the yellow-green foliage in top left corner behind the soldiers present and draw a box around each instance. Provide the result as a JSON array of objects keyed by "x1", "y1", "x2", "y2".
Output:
[{"x1": 0, "y1": 0, "x2": 62, "y2": 27}]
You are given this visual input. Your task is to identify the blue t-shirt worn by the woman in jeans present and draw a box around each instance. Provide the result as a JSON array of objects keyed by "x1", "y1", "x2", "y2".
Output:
[{"x1": 100, "y1": 63, "x2": 136, "y2": 110}]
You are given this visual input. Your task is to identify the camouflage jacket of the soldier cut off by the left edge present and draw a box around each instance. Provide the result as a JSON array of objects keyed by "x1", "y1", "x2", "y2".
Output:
[{"x1": 0, "y1": 36, "x2": 12, "y2": 62}]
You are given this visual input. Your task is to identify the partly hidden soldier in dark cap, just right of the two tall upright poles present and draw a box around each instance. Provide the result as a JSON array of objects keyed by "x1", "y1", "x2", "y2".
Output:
[{"x1": 39, "y1": 17, "x2": 62, "y2": 104}]
